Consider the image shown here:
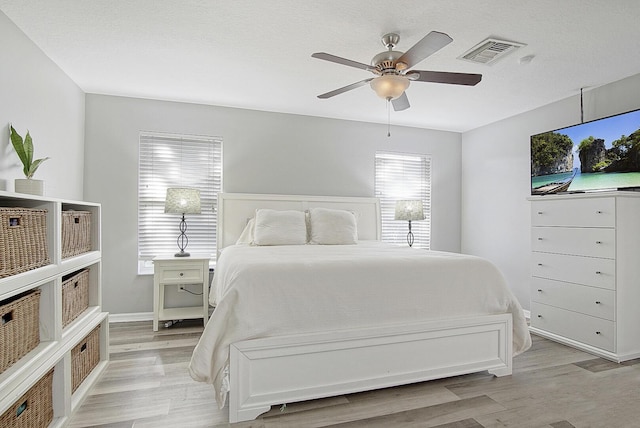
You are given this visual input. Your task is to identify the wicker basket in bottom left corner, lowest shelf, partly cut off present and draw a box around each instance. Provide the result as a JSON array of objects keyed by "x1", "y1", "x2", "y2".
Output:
[{"x1": 0, "y1": 369, "x2": 53, "y2": 428}]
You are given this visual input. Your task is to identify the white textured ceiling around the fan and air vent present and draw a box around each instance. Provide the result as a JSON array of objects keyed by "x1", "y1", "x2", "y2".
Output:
[{"x1": 0, "y1": 0, "x2": 640, "y2": 132}]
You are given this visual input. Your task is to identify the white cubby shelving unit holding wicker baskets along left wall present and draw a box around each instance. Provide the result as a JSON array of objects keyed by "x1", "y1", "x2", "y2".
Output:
[{"x1": 0, "y1": 191, "x2": 109, "y2": 427}]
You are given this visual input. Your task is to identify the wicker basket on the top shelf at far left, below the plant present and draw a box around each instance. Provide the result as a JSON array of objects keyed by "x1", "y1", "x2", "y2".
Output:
[{"x1": 0, "y1": 207, "x2": 50, "y2": 278}]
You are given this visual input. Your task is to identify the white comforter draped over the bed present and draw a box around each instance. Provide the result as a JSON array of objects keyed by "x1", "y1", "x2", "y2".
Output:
[{"x1": 189, "y1": 241, "x2": 531, "y2": 407}]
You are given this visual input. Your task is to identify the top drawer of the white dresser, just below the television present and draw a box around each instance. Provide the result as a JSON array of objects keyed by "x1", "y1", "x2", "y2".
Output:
[{"x1": 531, "y1": 198, "x2": 616, "y2": 227}]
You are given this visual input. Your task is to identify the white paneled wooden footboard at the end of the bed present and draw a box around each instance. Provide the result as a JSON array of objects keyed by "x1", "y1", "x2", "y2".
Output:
[{"x1": 229, "y1": 314, "x2": 513, "y2": 423}]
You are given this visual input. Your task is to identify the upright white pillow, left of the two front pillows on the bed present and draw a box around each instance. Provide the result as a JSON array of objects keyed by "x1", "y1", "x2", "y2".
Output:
[{"x1": 253, "y1": 209, "x2": 307, "y2": 245}]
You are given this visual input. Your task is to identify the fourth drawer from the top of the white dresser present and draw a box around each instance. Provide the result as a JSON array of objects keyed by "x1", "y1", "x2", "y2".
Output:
[{"x1": 531, "y1": 277, "x2": 616, "y2": 321}]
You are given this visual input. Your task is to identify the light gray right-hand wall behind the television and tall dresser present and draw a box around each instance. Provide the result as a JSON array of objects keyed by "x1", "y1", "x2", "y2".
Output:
[{"x1": 461, "y1": 74, "x2": 640, "y2": 309}]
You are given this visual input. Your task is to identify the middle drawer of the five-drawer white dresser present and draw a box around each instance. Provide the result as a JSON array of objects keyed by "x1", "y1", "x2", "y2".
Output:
[{"x1": 531, "y1": 251, "x2": 616, "y2": 290}]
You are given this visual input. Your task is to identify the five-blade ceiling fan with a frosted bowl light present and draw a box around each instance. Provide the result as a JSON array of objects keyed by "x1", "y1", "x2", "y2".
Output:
[{"x1": 311, "y1": 31, "x2": 482, "y2": 111}]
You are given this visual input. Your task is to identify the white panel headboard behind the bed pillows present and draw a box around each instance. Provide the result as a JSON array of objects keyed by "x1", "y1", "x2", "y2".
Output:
[{"x1": 216, "y1": 193, "x2": 381, "y2": 252}]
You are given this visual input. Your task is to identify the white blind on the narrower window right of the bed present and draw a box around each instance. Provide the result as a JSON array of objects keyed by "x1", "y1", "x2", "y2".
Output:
[{"x1": 375, "y1": 152, "x2": 431, "y2": 249}]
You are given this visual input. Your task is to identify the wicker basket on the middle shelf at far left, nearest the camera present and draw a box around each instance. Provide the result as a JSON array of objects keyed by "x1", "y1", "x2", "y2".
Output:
[{"x1": 0, "y1": 290, "x2": 40, "y2": 374}]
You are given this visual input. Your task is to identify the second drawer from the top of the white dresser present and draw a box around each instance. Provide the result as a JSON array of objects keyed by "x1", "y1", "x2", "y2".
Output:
[{"x1": 531, "y1": 226, "x2": 616, "y2": 259}]
